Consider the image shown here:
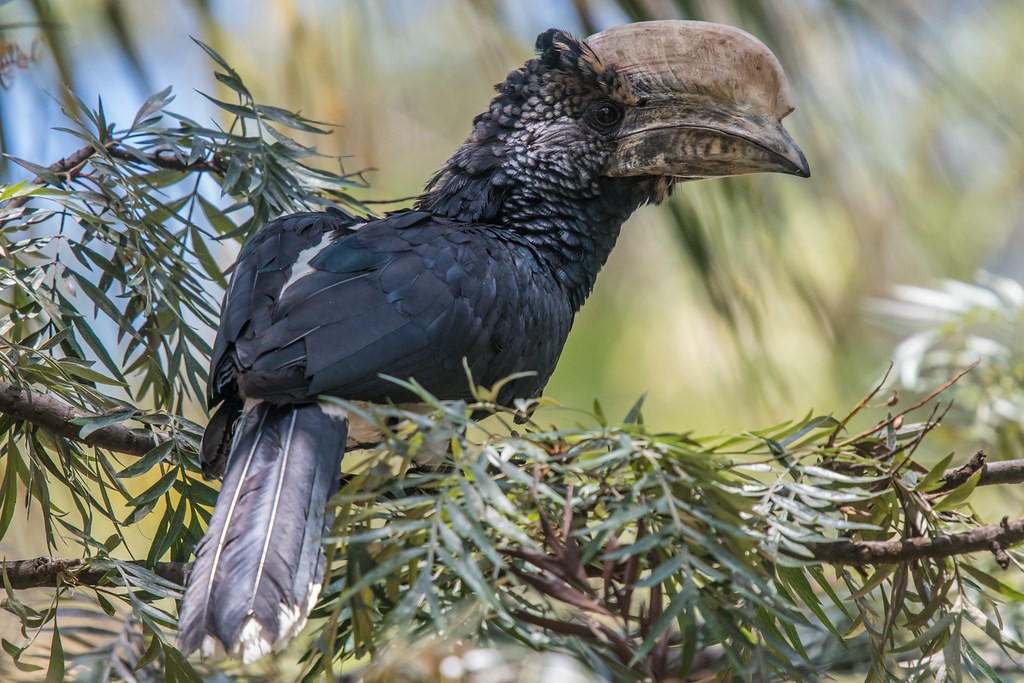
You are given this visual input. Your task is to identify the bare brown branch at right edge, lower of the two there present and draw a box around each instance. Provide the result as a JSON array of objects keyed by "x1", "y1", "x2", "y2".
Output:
[{"x1": 810, "y1": 517, "x2": 1024, "y2": 564}]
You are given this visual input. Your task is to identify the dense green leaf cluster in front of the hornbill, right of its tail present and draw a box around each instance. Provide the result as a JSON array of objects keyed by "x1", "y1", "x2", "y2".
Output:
[{"x1": 294, "y1": 385, "x2": 1024, "y2": 680}]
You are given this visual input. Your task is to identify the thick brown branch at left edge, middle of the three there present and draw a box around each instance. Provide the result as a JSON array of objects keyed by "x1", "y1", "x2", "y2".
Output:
[{"x1": 0, "y1": 381, "x2": 156, "y2": 456}]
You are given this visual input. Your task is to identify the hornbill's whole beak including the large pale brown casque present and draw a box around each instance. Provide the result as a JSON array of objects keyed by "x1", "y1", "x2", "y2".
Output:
[{"x1": 587, "y1": 20, "x2": 810, "y2": 178}]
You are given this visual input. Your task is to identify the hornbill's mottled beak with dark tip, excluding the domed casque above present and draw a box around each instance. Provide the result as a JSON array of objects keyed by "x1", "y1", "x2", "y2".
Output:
[{"x1": 605, "y1": 98, "x2": 811, "y2": 178}]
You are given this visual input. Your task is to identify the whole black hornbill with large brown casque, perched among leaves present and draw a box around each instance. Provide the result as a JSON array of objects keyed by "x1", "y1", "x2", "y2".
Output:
[{"x1": 179, "y1": 22, "x2": 809, "y2": 660}]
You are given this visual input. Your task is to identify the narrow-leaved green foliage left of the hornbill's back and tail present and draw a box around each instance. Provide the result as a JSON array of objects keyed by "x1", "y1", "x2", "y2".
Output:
[{"x1": 0, "y1": 46, "x2": 361, "y2": 676}]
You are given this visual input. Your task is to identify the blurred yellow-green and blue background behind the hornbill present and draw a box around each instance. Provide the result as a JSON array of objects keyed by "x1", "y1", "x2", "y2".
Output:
[{"x1": 8, "y1": 0, "x2": 1024, "y2": 433}]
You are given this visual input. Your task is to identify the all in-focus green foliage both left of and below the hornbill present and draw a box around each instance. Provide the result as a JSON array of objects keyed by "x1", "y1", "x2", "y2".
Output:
[{"x1": 0, "y1": 29, "x2": 1024, "y2": 681}]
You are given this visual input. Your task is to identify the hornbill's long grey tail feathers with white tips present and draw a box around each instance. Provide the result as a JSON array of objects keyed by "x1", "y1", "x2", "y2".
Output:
[{"x1": 178, "y1": 403, "x2": 348, "y2": 661}]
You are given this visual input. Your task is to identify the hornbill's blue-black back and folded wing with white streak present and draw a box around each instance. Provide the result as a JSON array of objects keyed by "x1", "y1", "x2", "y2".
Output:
[{"x1": 210, "y1": 211, "x2": 572, "y2": 411}]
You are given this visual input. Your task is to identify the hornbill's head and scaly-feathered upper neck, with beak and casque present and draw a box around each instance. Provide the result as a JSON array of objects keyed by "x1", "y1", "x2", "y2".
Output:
[{"x1": 420, "y1": 20, "x2": 809, "y2": 221}]
